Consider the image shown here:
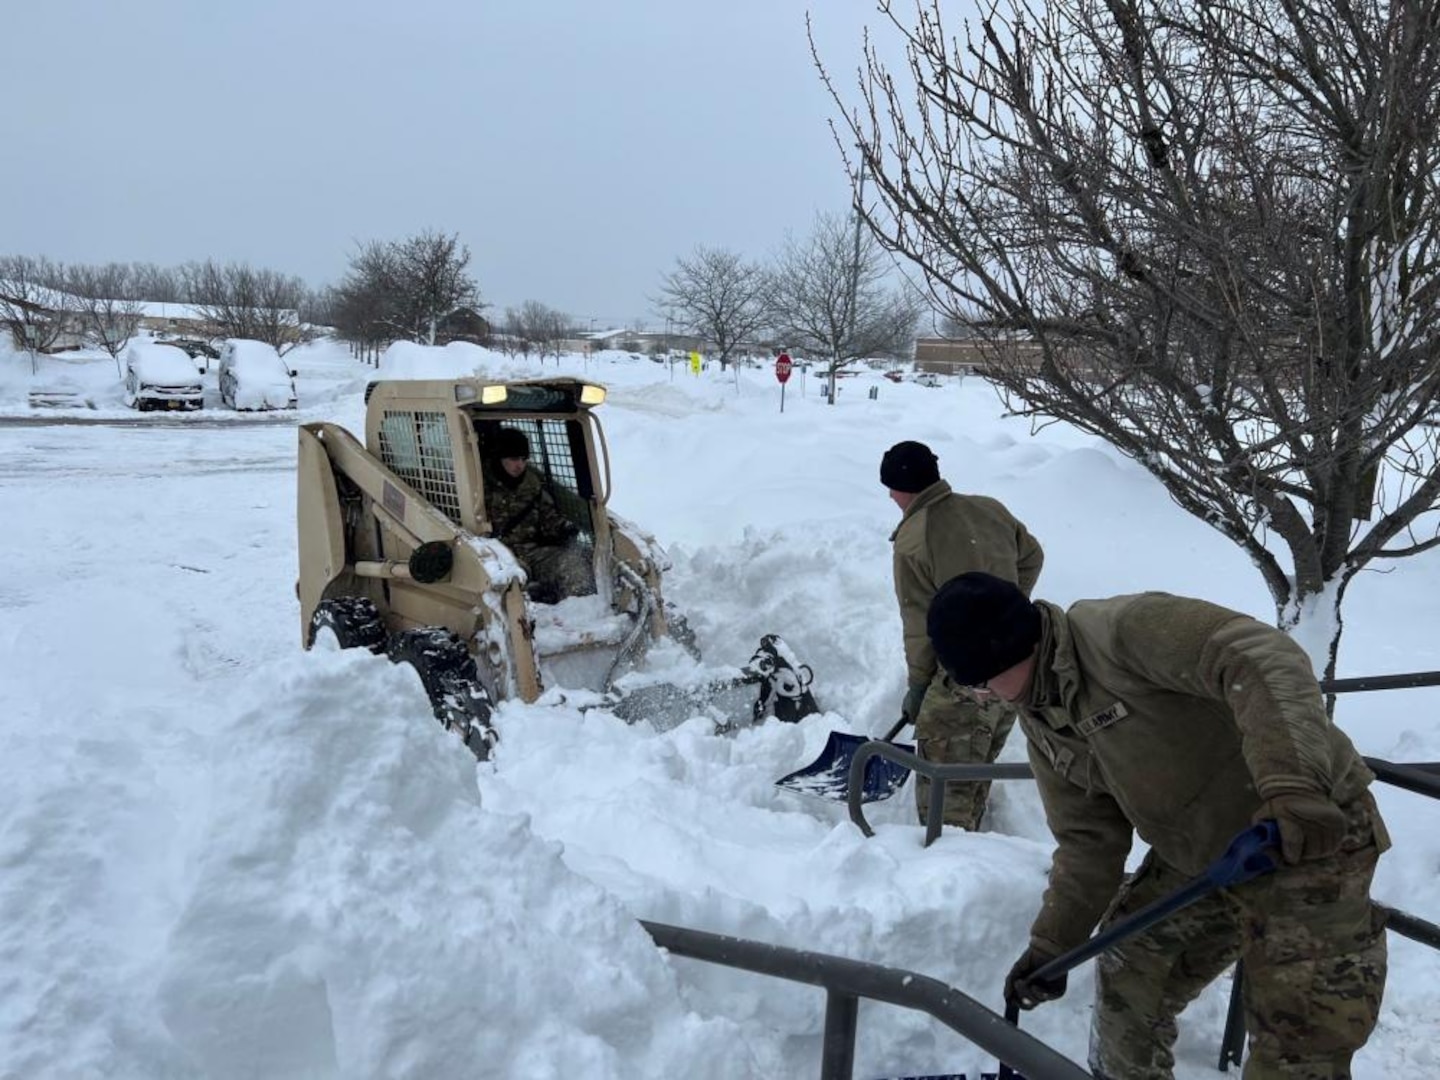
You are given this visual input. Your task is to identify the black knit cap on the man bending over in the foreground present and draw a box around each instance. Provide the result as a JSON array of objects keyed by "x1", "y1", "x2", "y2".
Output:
[{"x1": 924, "y1": 570, "x2": 1040, "y2": 687}]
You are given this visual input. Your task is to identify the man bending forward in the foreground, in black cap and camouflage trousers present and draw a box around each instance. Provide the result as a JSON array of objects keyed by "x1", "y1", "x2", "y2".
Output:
[{"x1": 927, "y1": 573, "x2": 1390, "y2": 1080}]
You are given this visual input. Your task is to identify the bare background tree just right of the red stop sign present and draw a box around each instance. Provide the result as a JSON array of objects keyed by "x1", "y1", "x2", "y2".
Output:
[{"x1": 769, "y1": 213, "x2": 920, "y2": 403}]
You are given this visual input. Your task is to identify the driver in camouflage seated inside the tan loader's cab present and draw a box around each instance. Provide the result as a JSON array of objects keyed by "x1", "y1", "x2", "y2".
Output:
[{"x1": 485, "y1": 428, "x2": 595, "y2": 603}]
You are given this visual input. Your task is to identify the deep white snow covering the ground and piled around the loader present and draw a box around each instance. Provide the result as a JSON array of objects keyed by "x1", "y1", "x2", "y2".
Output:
[{"x1": 0, "y1": 343, "x2": 1440, "y2": 1080}]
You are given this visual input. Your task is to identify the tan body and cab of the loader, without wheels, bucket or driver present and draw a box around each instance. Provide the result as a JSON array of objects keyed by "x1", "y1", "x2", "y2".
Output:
[{"x1": 297, "y1": 379, "x2": 670, "y2": 722}]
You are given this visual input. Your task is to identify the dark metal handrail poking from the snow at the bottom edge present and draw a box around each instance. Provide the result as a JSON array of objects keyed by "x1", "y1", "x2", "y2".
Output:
[{"x1": 641, "y1": 919, "x2": 1093, "y2": 1080}]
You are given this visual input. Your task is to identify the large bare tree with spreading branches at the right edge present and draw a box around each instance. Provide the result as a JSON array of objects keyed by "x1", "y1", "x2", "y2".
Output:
[{"x1": 832, "y1": 0, "x2": 1440, "y2": 685}]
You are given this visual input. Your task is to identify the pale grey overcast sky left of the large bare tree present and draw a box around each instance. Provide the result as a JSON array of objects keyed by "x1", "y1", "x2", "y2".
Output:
[{"x1": 0, "y1": 0, "x2": 894, "y2": 324}]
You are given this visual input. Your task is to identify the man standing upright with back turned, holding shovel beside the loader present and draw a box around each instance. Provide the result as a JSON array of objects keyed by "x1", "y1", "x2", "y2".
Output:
[{"x1": 880, "y1": 442, "x2": 1045, "y2": 831}]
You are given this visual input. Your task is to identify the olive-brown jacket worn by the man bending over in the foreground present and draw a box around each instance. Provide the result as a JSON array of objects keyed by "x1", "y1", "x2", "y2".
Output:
[{"x1": 1020, "y1": 592, "x2": 1388, "y2": 953}]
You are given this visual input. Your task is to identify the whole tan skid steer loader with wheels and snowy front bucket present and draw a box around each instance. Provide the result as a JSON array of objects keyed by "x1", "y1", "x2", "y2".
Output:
[{"x1": 297, "y1": 377, "x2": 819, "y2": 759}]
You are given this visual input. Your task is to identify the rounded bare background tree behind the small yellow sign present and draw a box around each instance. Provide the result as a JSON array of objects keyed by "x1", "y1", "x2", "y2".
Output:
[{"x1": 657, "y1": 245, "x2": 769, "y2": 372}]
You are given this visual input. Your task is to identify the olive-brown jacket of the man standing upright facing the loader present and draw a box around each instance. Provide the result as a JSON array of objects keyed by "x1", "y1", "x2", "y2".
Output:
[{"x1": 890, "y1": 480, "x2": 1045, "y2": 685}]
